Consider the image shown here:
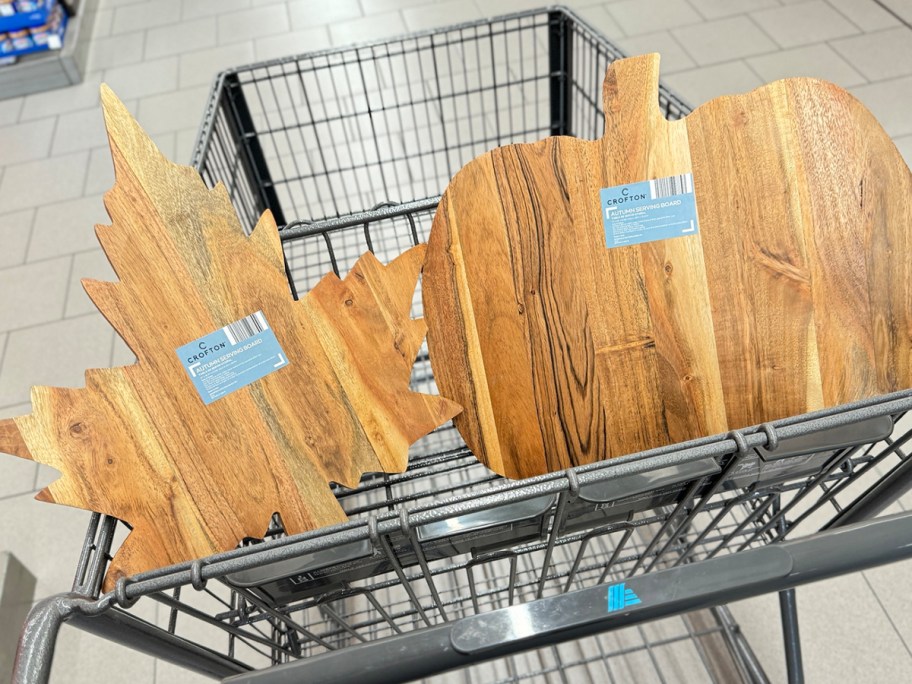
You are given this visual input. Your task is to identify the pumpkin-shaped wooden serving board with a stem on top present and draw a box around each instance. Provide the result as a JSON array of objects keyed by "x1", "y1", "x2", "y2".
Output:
[{"x1": 423, "y1": 55, "x2": 912, "y2": 477}]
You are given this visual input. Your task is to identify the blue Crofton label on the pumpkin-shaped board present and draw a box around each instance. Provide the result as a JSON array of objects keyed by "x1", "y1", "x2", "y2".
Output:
[{"x1": 601, "y1": 173, "x2": 699, "y2": 247}]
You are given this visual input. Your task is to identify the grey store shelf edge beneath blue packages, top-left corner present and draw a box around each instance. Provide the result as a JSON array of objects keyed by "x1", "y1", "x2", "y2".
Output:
[{"x1": 0, "y1": 0, "x2": 99, "y2": 100}]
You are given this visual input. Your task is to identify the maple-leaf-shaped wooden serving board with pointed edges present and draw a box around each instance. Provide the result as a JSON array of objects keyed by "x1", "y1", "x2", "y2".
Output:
[{"x1": 0, "y1": 86, "x2": 458, "y2": 589}]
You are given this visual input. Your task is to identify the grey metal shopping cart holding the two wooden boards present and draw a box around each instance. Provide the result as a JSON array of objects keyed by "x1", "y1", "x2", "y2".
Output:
[{"x1": 16, "y1": 8, "x2": 912, "y2": 684}]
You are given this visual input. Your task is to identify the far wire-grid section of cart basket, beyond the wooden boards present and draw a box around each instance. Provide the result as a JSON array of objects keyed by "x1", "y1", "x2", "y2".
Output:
[{"x1": 194, "y1": 10, "x2": 687, "y2": 229}]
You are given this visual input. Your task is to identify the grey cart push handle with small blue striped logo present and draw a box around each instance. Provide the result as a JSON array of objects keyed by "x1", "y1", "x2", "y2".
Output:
[{"x1": 224, "y1": 513, "x2": 912, "y2": 684}]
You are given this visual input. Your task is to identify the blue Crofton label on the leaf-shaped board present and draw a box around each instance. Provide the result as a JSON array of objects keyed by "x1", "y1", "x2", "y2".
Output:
[{"x1": 177, "y1": 311, "x2": 288, "y2": 405}]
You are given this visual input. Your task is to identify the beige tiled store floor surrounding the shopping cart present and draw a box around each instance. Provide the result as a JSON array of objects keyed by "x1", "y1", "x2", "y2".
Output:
[{"x1": 0, "y1": 0, "x2": 912, "y2": 684}]
